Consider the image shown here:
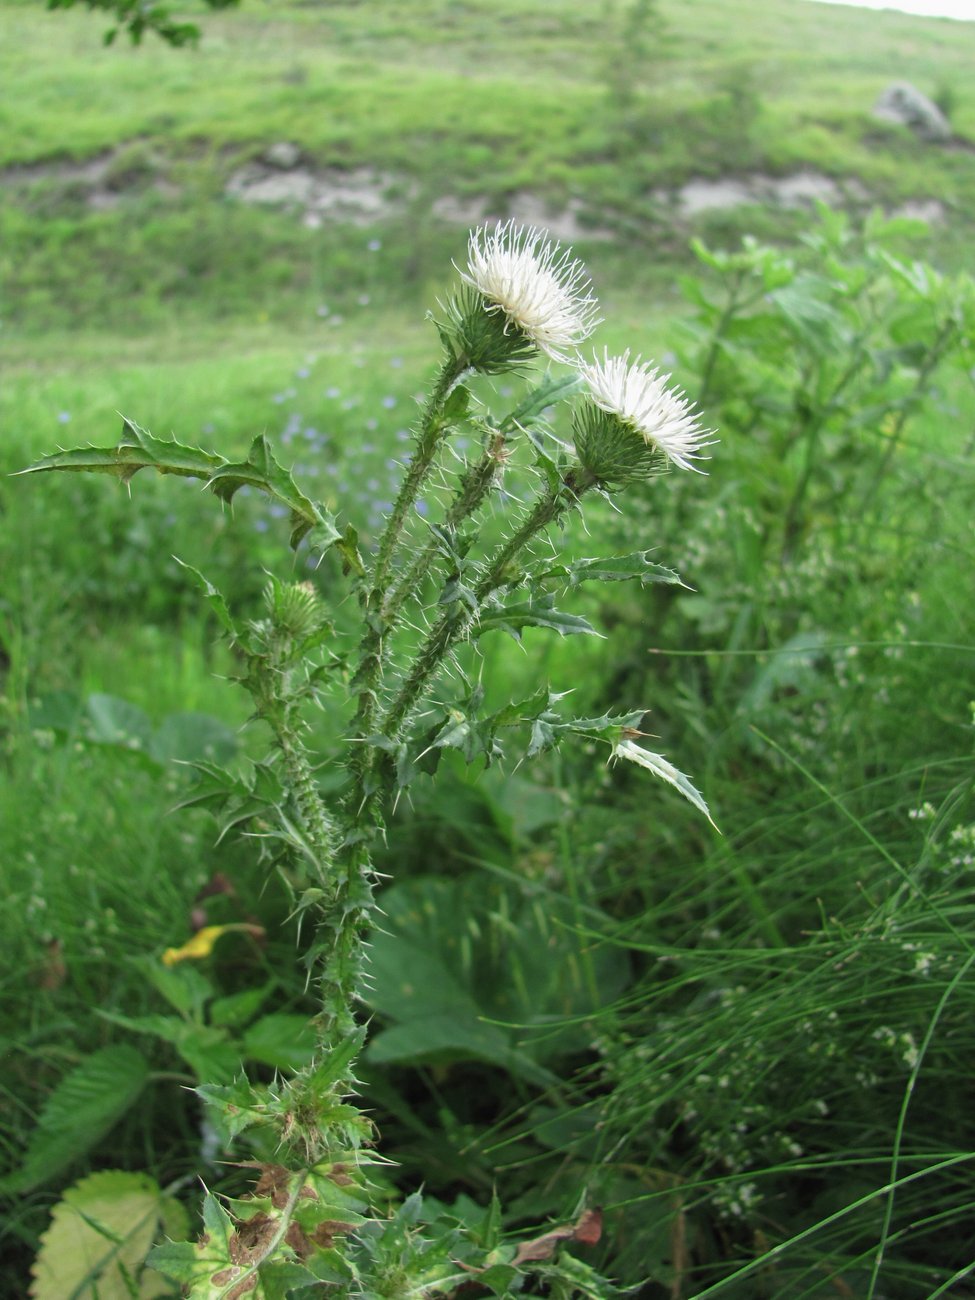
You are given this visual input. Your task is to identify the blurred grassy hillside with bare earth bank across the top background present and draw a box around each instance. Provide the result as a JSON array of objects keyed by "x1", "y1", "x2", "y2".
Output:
[{"x1": 0, "y1": 0, "x2": 975, "y2": 333}]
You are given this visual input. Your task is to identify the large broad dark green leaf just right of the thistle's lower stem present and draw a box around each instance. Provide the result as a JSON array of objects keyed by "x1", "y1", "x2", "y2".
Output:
[{"x1": 367, "y1": 875, "x2": 629, "y2": 1083}]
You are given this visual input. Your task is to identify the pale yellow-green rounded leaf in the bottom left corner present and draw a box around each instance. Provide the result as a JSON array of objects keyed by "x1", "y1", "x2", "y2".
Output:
[{"x1": 30, "y1": 1170, "x2": 169, "y2": 1300}]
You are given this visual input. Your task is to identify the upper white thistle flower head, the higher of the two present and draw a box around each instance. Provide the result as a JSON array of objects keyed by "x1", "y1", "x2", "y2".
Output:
[{"x1": 458, "y1": 221, "x2": 599, "y2": 363}]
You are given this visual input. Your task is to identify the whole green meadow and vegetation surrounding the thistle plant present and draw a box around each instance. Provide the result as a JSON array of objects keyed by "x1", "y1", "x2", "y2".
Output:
[{"x1": 0, "y1": 0, "x2": 975, "y2": 1300}]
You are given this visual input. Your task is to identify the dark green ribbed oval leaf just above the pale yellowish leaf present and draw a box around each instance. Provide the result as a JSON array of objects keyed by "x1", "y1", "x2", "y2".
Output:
[{"x1": 3, "y1": 1044, "x2": 150, "y2": 1191}]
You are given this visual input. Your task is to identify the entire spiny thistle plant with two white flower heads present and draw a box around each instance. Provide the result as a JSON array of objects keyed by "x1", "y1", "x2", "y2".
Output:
[{"x1": 19, "y1": 224, "x2": 709, "y2": 1300}]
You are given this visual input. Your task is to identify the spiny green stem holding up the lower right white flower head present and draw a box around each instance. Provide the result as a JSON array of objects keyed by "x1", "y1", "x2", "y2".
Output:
[{"x1": 380, "y1": 468, "x2": 597, "y2": 740}]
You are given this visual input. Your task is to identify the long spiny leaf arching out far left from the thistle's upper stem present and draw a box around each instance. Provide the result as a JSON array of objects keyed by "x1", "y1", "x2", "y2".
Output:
[{"x1": 21, "y1": 419, "x2": 343, "y2": 551}]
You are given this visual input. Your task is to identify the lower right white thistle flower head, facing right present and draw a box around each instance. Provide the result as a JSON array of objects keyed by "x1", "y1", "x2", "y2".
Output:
[{"x1": 579, "y1": 351, "x2": 716, "y2": 473}]
